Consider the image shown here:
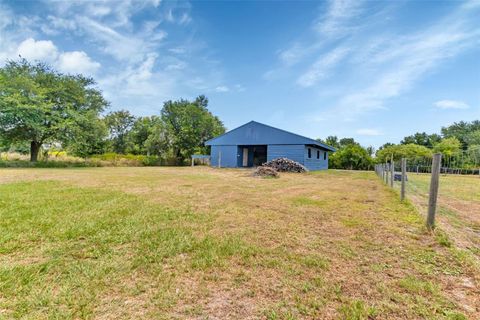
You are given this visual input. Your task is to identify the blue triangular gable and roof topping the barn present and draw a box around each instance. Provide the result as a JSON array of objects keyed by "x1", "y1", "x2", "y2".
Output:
[{"x1": 205, "y1": 121, "x2": 336, "y2": 151}]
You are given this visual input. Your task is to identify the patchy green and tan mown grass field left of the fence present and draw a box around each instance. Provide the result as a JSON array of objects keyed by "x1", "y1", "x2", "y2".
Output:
[{"x1": 0, "y1": 167, "x2": 480, "y2": 319}]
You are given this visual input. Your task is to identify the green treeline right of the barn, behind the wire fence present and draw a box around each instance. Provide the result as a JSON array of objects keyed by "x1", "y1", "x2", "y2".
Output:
[{"x1": 318, "y1": 120, "x2": 480, "y2": 170}]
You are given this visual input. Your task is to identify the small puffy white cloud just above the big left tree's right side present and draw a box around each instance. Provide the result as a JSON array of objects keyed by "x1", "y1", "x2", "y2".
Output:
[{"x1": 57, "y1": 51, "x2": 100, "y2": 75}]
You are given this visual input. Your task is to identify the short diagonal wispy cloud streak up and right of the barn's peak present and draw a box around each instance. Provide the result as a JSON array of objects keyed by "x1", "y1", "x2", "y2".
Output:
[{"x1": 297, "y1": 47, "x2": 349, "y2": 87}]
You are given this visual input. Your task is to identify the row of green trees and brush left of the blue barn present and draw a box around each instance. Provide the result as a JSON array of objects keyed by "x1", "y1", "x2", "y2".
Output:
[{"x1": 0, "y1": 59, "x2": 225, "y2": 165}]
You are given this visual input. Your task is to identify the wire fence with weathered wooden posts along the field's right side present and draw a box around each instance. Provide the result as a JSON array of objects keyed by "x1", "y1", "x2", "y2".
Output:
[{"x1": 375, "y1": 148, "x2": 480, "y2": 259}]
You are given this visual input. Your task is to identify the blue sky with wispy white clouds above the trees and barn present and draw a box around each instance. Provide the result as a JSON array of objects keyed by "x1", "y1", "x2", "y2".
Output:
[{"x1": 0, "y1": 0, "x2": 480, "y2": 147}]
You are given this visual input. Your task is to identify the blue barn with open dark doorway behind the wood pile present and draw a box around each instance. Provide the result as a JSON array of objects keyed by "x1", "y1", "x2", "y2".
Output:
[{"x1": 205, "y1": 121, "x2": 335, "y2": 170}]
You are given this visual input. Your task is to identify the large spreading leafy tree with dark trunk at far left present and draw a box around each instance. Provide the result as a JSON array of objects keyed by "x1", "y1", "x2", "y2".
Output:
[{"x1": 0, "y1": 59, "x2": 108, "y2": 161}]
